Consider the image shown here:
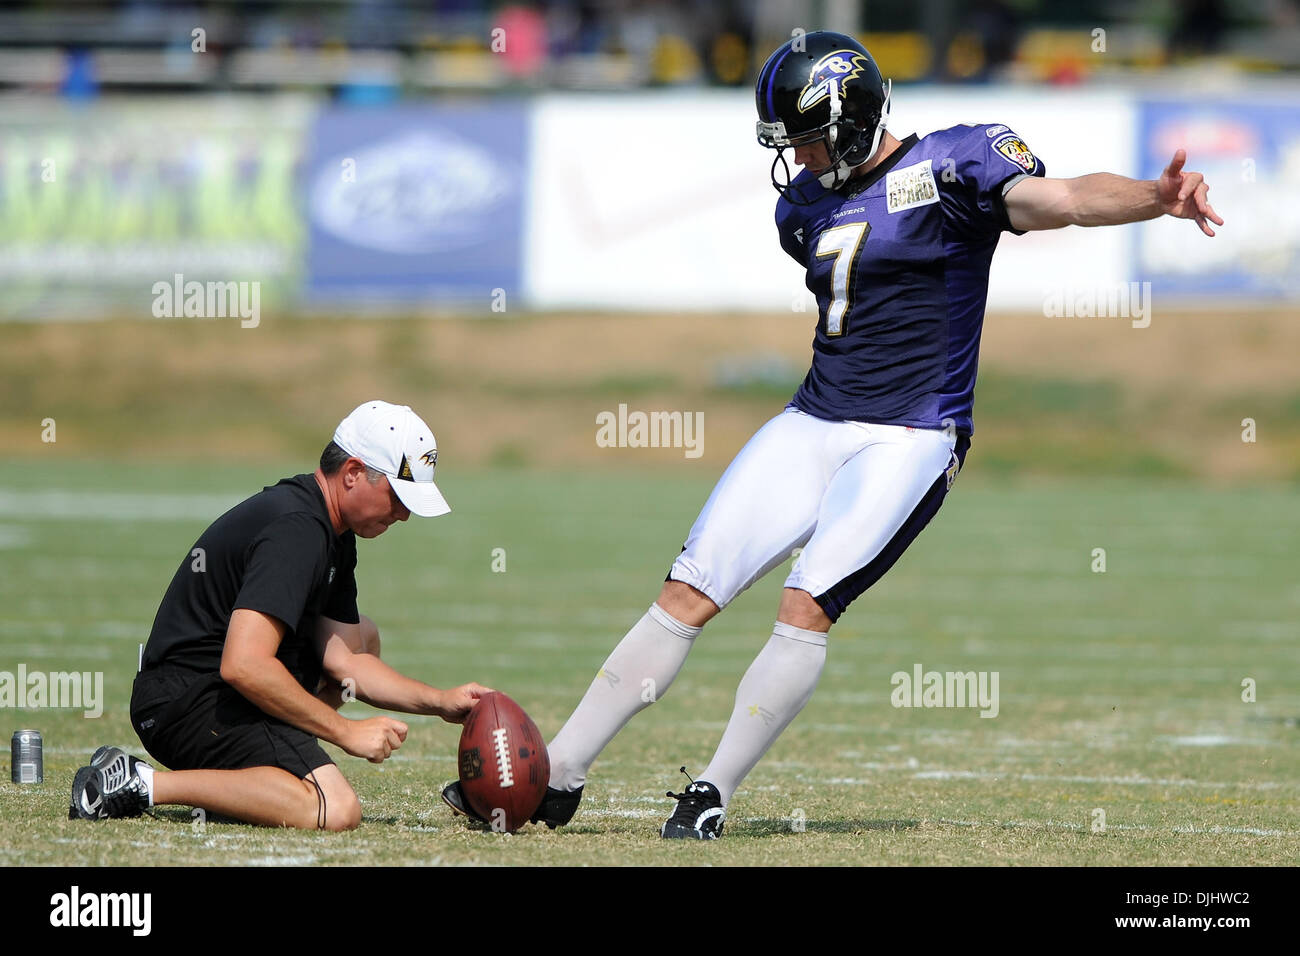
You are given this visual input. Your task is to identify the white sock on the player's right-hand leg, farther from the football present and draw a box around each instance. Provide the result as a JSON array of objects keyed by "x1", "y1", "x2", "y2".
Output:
[{"x1": 696, "y1": 622, "x2": 826, "y2": 805}]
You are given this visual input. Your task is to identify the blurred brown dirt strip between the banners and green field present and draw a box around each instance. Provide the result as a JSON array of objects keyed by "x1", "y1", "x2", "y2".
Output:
[{"x1": 0, "y1": 310, "x2": 1300, "y2": 479}]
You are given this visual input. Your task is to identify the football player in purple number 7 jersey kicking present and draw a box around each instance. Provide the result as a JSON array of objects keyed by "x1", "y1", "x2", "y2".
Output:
[{"x1": 445, "y1": 33, "x2": 1223, "y2": 839}]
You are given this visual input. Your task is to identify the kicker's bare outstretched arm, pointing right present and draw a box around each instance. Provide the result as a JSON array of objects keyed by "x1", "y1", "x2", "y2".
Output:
[{"x1": 1006, "y1": 150, "x2": 1223, "y2": 235}]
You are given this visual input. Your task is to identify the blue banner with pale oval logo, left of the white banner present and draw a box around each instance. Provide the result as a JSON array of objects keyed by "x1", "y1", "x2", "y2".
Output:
[{"x1": 304, "y1": 100, "x2": 528, "y2": 304}]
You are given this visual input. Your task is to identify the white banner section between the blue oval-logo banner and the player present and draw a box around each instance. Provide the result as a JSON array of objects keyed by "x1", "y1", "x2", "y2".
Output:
[{"x1": 527, "y1": 91, "x2": 785, "y2": 311}]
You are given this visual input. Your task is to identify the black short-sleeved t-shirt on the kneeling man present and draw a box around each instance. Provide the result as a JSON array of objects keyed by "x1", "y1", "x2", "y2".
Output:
[{"x1": 144, "y1": 475, "x2": 360, "y2": 691}]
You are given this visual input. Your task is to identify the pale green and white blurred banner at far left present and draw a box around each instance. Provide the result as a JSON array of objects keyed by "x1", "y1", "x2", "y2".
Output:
[{"x1": 0, "y1": 96, "x2": 313, "y2": 319}]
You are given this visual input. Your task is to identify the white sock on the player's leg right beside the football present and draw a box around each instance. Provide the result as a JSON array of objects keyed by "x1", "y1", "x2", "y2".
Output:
[{"x1": 546, "y1": 604, "x2": 702, "y2": 790}]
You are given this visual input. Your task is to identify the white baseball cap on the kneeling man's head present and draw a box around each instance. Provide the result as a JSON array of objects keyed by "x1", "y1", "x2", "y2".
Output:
[{"x1": 334, "y1": 401, "x2": 451, "y2": 518}]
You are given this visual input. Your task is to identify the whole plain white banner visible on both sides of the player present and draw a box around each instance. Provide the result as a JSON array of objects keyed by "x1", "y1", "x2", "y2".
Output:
[{"x1": 525, "y1": 86, "x2": 1139, "y2": 311}]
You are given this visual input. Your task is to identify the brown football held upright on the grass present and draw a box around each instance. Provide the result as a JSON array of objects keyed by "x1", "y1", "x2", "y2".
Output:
[{"x1": 456, "y1": 691, "x2": 551, "y2": 834}]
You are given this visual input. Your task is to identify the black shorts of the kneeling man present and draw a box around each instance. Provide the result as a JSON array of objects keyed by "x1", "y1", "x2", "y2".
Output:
[{"x1": 131, "y1": 666, "x2": 334, "y2": 779}]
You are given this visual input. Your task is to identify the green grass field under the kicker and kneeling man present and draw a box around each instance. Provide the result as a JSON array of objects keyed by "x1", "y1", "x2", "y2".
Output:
[{"x1": 0, "y1": 463, "x2": 1300, "y2": 866}]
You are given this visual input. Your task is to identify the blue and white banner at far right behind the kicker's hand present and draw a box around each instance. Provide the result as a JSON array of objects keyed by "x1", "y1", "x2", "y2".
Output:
[{"x1": 1135, "y1": 95, "x2": 1300, "y2": 300}]
